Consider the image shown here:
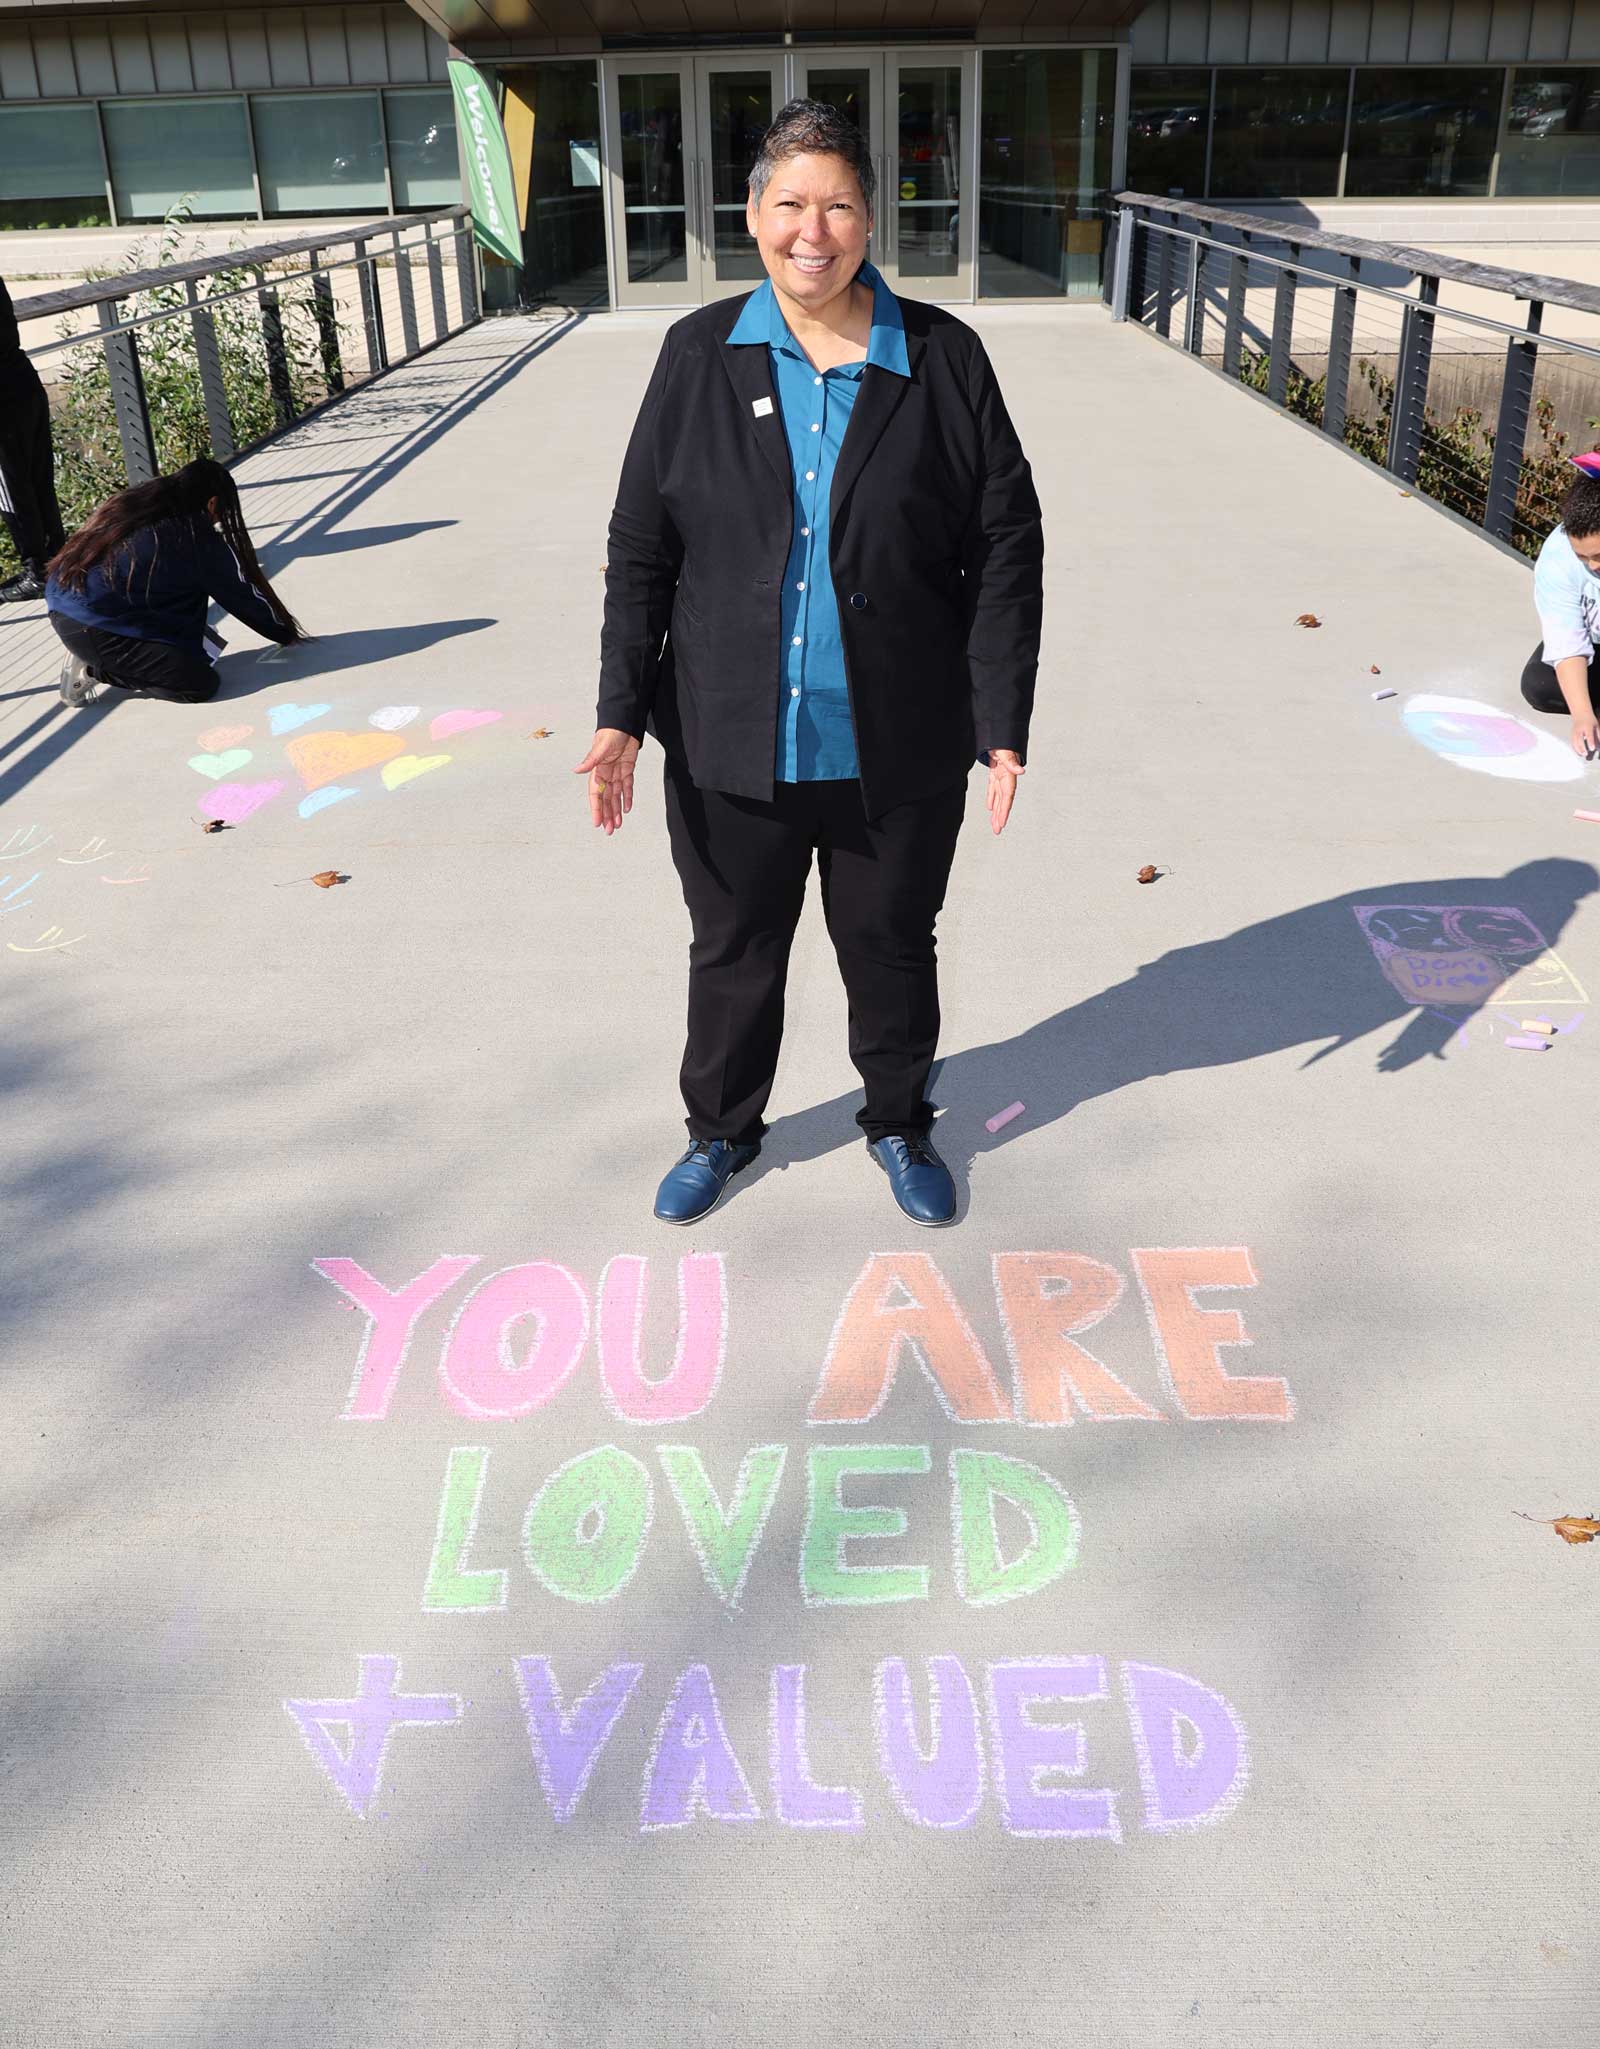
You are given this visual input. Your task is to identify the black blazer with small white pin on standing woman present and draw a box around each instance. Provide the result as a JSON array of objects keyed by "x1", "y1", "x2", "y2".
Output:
[{"x1": 596, "y1": 299, "x2": 1043, "y2": 818}]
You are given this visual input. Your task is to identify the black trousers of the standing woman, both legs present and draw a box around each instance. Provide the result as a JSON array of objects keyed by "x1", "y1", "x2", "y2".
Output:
[{"x1": 666, "y1": 758, "x2": 967, "y2": 1145}]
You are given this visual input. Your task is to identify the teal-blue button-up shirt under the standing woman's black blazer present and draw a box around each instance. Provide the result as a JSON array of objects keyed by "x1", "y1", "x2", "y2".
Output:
[{"x1": 727, "y1": 262, "x2": 912, "y2": 783}]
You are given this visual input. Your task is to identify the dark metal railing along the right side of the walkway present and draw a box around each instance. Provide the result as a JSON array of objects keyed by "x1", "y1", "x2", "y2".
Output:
[{"x1": 1104, "y1": 193, "x2": 1600, "y2": 555}]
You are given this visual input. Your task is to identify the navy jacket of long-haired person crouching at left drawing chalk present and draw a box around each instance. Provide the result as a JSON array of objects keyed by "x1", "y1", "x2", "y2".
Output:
[{"x1": 45, "y1": 514, "x2": 289, "y2": 647}]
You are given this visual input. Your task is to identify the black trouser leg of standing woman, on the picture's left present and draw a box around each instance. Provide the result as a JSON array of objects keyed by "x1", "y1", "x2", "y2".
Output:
[{"x1": 666, "y1": 758, "x2": 815, "y2": 1145}]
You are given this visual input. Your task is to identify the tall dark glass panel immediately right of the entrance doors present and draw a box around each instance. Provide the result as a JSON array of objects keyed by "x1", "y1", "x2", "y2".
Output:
[{"x1": 977, "y1": 49, "x2": 1117, "y2": 299}]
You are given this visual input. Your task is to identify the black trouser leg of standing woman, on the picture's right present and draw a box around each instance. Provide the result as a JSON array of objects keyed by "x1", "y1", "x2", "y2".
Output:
[{"x1": 815, "y1": 783, "x2": 967, "y2": 1139}]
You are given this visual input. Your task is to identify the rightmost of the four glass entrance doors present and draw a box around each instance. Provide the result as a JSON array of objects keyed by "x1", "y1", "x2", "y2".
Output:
[{"x1": 879, "y1": 51, "x2": 977, "y2": 299}]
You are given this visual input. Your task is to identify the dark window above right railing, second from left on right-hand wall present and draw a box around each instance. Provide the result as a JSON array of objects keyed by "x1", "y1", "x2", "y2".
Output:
[{"x1": 1211, "y1": 70, "x2": 1350, "y2": 199}]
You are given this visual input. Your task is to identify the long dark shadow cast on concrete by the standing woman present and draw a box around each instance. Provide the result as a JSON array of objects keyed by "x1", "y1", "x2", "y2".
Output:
[{"x1": 752, "y1": 859, "x2": 1600, "y2": 1178}]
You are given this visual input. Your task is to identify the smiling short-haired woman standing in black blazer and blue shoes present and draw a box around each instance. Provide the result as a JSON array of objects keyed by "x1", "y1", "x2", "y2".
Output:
[{"x1": 578, "y1": 100, "x2": 1043, "y2": 1223}]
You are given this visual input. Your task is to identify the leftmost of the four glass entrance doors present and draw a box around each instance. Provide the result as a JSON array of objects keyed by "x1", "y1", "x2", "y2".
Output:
[{"x1": 602, "y1": 57, "x2": 701, "y2": 307}]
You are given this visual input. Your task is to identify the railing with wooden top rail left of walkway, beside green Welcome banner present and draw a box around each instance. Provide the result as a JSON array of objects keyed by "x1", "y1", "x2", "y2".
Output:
[{"x1": 16, "y1": 207, "x2": 483, "y2": 488}]
